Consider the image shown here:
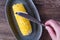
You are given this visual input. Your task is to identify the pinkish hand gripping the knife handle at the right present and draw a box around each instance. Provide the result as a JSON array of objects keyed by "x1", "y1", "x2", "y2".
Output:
[{"x1": 45, "y1": 19, "x2": 60, "y2": 40}]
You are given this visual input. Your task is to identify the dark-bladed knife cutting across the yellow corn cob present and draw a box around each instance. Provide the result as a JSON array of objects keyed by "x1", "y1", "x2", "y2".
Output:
[{"x1": 16, "y1": 12, "x2": 45, "y2": 26}]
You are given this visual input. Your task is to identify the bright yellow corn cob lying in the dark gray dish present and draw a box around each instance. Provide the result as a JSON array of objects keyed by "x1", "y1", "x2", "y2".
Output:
[{"x1": 12, "y1": 3, "x2": 32, "y2": 36}]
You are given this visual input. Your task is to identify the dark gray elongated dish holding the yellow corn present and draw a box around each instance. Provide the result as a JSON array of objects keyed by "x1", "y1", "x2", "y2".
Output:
[{"x1": 5, "y1": 0, "x2": 42, "y2": 40}]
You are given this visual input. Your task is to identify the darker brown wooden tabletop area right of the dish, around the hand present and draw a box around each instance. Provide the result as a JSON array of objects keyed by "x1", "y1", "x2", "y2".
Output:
[{"x1": 34, "y1": 0, "x2": 60, "y2": 40}]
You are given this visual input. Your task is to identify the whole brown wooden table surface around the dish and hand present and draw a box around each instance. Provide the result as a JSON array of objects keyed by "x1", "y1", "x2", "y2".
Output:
[{"x1": 0, "y1": 0, "x2": 60, "y2": 40}]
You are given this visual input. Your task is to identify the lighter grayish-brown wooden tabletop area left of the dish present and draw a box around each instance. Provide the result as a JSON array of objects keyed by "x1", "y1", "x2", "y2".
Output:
[{"x1": 0, "y1": 0, "x2": 16, "y2": 40}]
